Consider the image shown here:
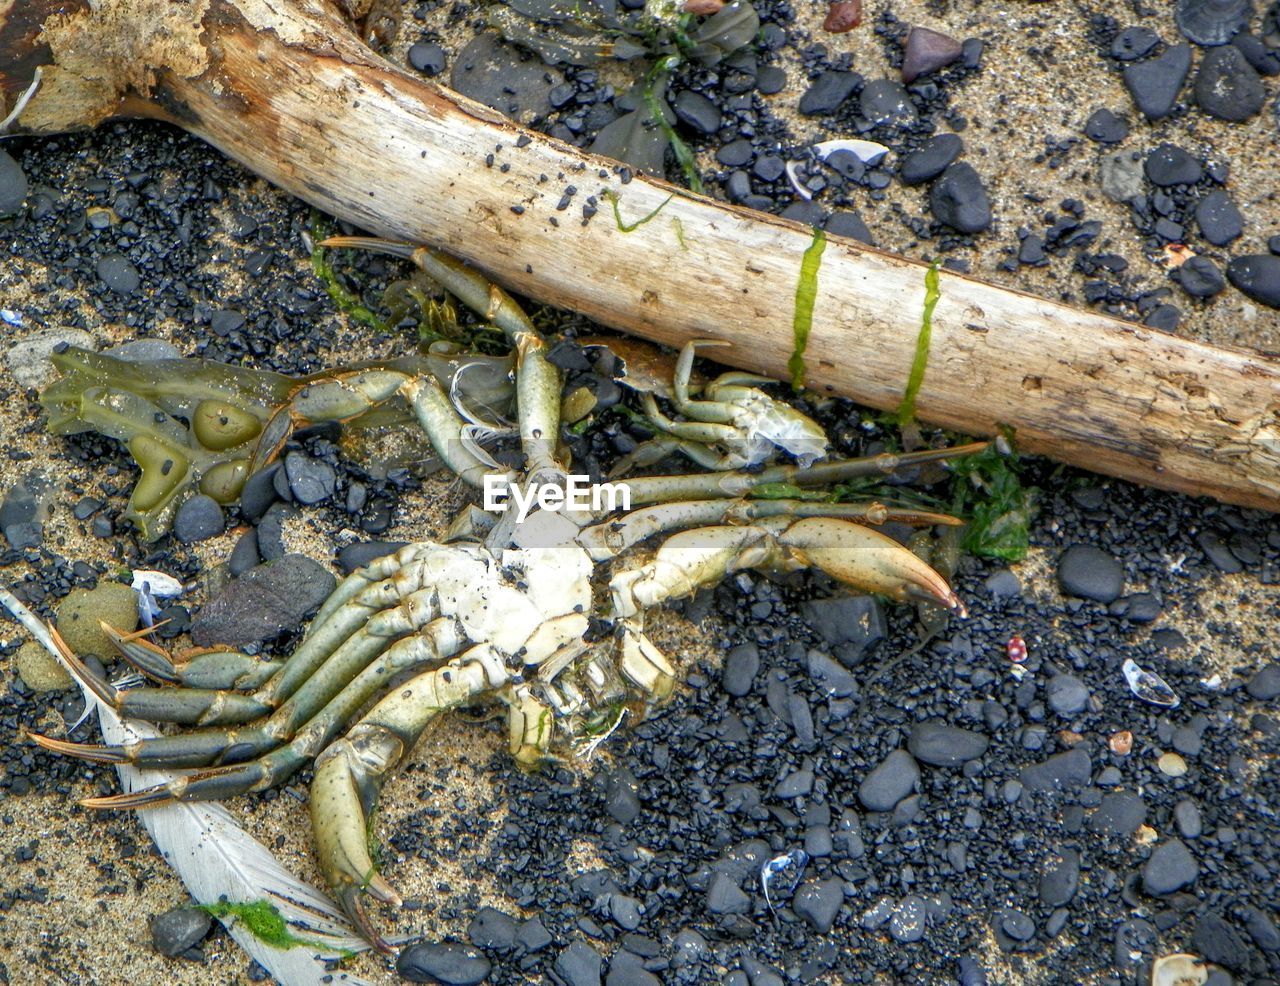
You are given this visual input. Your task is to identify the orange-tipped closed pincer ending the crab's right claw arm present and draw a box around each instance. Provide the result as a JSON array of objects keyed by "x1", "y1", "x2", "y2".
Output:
[{"x1": 777, "y1": 517, "x2": 966, "y2": 616}]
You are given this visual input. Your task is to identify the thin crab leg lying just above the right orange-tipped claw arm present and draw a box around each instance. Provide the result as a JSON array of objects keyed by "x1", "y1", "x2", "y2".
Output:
[{"x1": 575, "y1": 499, "x2": 964, "y2": 561}]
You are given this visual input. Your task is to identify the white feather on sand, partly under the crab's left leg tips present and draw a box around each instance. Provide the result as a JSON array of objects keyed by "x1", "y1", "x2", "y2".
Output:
[{"x1": 0, "y1": 589, "x2": 369, "y2": 986}]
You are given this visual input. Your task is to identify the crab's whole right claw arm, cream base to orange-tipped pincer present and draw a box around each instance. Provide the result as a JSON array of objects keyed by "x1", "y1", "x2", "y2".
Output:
[{"x1": 609, "y1": 517, "x2": 963, "y2": 617}]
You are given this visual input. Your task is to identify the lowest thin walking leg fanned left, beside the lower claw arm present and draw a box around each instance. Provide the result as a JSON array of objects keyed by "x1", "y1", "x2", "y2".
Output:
[{"x1": 74, "y1": 620, "x2": 465, "y2": 808}]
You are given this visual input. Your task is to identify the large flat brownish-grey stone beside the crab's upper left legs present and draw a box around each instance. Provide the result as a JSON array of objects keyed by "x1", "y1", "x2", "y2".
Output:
[{"x1": 191, "y1": 554, "x2": 337, "y2": 647}]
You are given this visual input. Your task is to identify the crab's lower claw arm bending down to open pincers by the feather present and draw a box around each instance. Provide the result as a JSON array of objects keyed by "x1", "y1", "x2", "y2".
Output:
[{"x1": 311, "y1": 644, "x2": 507, "y2": 950}]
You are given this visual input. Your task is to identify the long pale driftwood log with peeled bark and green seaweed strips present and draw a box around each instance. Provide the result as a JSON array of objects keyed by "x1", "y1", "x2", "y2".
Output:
[{"x1": 0, "y1": 0, "x2": 1280, "y2": 510}]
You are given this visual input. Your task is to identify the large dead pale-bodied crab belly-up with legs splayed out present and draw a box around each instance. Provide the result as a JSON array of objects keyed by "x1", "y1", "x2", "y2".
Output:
[{"x1": 33, "y1": 238, "x2": 983, "y2": 950}]
